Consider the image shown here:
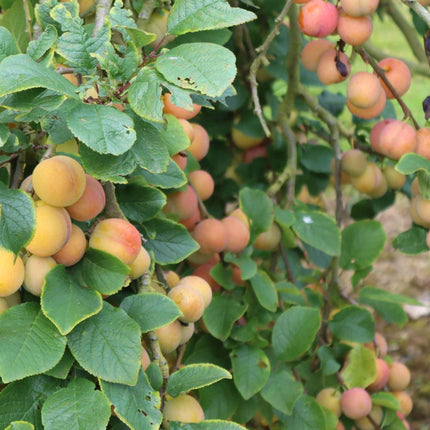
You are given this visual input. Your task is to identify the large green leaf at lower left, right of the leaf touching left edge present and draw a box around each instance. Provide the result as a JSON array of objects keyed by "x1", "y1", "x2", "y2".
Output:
[{"x1": 67, "y1": 302, "x2": 142, "y2": 385}]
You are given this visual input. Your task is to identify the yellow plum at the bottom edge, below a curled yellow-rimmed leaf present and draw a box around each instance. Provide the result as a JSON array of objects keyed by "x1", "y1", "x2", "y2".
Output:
[{"x1": 163, "y1": 394, "x2": 205, "y2": 429}]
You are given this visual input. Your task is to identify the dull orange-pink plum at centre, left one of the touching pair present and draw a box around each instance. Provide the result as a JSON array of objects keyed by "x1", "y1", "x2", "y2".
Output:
[{"x1": 192, "y1": 218, "x2": 227, "y2": 254}]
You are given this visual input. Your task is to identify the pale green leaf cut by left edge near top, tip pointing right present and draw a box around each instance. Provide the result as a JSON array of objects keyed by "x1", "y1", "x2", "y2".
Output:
[{"x1": 0, "y1": 54, "x2": 77, "y2": 98}]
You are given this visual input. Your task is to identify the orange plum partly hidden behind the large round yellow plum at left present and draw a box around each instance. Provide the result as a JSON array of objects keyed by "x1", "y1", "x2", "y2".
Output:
[{"x1": 66, "y1": 175, "x2": 106, "y2": 221}]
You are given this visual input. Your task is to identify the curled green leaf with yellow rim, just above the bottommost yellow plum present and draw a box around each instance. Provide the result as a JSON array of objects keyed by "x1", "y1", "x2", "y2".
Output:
[{"x1": 167, "y1": 363, "x2": 231, "y2": 397}]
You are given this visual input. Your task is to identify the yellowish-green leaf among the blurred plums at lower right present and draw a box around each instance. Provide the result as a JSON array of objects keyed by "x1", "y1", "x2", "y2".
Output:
[{"x1": 341, "y1": 343, "x2": 376, "y2": 388}]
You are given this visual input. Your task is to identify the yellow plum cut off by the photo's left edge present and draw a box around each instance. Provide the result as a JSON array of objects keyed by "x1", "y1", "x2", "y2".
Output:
[{"x1": 0, "y1": 247, "x2": 24, "y2": 297}]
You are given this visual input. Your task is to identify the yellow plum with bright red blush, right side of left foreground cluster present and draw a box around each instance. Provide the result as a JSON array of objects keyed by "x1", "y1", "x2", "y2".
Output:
[{"x1": 89, "y1": 218, "x2": 142, "y2": 264}]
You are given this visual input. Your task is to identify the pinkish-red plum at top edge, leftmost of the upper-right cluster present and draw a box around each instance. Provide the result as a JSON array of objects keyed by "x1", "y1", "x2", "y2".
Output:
[{"x1": 298, "y1": 0, "x2": 338, "y2": 37}]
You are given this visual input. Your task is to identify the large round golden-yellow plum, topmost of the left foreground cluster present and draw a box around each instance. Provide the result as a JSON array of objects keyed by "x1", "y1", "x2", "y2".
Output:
[{"x1": 33, "y1": 155, "x2": 86, "y2": 207}]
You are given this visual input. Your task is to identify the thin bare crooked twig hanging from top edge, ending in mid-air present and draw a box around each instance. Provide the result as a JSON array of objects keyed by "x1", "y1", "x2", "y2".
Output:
[{"x1": 249, "y1": 0, "x2": 293, "y2": 137}]
